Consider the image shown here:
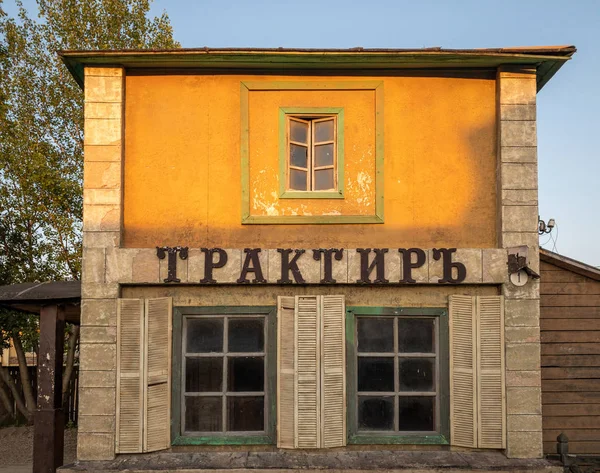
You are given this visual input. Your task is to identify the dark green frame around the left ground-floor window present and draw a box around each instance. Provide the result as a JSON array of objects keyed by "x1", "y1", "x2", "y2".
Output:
[{"x1": 171, "y1": 306, "x2": 277, "y2": 446}]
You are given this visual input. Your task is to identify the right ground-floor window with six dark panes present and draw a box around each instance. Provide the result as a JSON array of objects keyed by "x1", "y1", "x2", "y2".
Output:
[{"x1": 346, "y1": 307, "x2": 448, "y2": 443}]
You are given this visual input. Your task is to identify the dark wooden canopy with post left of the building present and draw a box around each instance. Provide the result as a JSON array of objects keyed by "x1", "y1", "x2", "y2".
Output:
[{"x1": 0, "y1": 281, "x2": 81, "y2": 473}]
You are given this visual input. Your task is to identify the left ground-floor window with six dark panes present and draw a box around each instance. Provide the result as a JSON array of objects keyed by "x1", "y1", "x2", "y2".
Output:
[{"x1": 173, "y1": 307, "x2": 276, "y2": 444}]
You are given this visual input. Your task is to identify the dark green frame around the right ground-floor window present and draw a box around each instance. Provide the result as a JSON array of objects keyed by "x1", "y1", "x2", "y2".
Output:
[{"x1": 346, "y1": 306, "x2": 450, "y2": 445}]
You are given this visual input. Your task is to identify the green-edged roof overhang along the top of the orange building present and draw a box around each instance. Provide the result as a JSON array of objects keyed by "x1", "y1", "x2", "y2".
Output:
[{"x1": 58, "y1": 46, "x2": 576, "y2": 91}]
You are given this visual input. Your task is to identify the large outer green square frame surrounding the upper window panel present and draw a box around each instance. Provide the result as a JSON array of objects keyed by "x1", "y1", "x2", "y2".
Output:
[{"x1": 240, "y1": 80, "x2": 384, "y2": 225}]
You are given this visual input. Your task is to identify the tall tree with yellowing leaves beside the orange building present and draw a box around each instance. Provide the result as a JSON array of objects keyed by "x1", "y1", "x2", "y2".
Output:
[{"x1": 0, "y1": 0, "x2": 179, "y2": 418}]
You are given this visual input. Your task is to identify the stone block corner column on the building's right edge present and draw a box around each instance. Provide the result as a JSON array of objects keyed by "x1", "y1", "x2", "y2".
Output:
[{"x1": 496, "y1": 66, "x2": 543, "y2": 458}]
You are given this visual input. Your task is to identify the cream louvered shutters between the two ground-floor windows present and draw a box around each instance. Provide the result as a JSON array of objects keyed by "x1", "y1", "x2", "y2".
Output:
[{"x1": 277, "y1": 296, "x2": 346, "y2": 448}]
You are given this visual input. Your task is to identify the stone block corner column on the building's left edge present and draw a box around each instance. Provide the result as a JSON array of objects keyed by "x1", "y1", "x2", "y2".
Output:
[{"x1": 77, "y1": 67, "x2": 125, "y2": 460}]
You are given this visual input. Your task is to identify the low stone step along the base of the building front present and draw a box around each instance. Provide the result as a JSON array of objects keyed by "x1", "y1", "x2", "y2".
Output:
[{"x1": 59, "y1": 450, "x2": 563, "y2": 473}]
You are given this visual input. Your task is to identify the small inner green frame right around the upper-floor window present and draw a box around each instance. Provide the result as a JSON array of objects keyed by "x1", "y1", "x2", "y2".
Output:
[{"x1": 279, "y1": 107, "x2": 344, "y2": 199}]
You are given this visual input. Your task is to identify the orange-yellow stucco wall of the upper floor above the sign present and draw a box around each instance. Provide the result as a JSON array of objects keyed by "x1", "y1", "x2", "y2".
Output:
[{"x1": 123, "y1": 75, "x2": 496, "y2": 248}]
